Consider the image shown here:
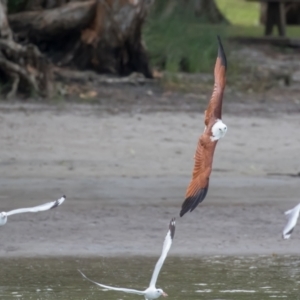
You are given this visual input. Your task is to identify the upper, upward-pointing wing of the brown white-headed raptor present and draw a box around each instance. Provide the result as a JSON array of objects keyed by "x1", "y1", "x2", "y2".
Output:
[{"x1": 205, "y1": 36, "x2": 227, "y2": 126}]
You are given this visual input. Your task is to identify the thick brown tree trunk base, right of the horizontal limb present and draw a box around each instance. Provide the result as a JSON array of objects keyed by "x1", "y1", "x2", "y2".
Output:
[{"x1": 73, "y1": 0, "x2": 152, "y2": 77}]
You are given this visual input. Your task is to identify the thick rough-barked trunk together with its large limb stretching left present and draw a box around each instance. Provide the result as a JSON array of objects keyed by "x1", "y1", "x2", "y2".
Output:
[{"x1": 9, "y1": 0, "x2": 153, "y2": 77}]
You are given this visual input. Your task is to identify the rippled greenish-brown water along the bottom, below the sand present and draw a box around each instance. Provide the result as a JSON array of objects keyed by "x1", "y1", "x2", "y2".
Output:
[{"x1": 0, "y1": 256, "x2": 300, "y2": 300}]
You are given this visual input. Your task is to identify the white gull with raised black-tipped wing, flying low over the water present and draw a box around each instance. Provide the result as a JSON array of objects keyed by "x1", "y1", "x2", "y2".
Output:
[{"x1": 78, "y1": 219, "x2": 175, "y2": 300}]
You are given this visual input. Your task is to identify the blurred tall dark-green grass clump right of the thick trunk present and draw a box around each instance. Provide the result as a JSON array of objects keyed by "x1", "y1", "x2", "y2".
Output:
[{"x1": 144, "y1": 1, "x2": 226, "y2": 73}]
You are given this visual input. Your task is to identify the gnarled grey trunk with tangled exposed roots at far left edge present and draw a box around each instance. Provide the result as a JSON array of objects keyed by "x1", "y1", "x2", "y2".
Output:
[{"x1": 0, "y1": 0, "x2": 51, "y2": 98}]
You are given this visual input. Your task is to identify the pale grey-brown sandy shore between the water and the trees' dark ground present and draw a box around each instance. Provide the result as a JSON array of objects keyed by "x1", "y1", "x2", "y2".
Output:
[{"x1": 0, "y1": 105, "x2": 300, "y2": 257}]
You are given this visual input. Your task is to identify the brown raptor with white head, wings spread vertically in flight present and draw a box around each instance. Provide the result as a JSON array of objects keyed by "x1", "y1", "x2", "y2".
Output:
[{"x1": 180, "y1": 37, "x2": 227, "y2": 217}]
